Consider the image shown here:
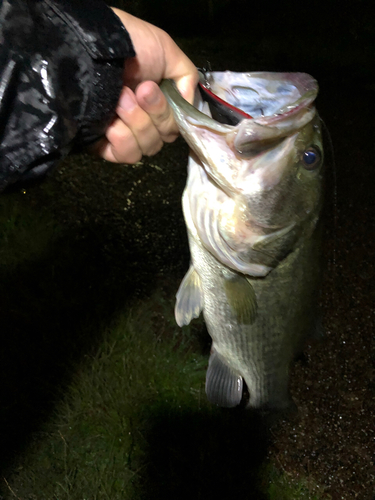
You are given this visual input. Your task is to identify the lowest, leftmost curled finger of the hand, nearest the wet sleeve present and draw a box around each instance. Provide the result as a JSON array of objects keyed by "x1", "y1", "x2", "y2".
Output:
[{"x1": 102, "y1": 118, "x2": 142, "y2": 163}]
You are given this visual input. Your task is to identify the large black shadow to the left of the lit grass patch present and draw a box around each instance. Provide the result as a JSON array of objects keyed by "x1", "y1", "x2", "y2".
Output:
[{"x1": 0, "y1": 225, "x2": 160, "y2": 473}]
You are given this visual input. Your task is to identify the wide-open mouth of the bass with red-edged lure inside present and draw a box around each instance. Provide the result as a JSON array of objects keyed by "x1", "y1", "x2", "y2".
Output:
[{"x1": 160, "y1": 71, "x2": 319, "y2": 135}]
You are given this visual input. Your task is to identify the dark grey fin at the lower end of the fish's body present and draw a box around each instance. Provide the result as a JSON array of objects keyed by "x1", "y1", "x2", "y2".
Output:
[{"x1": 206, "y1": 351, "x2": 243, "y2": 408}]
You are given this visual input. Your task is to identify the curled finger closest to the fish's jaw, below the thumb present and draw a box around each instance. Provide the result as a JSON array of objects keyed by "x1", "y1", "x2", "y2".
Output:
[{"x1": 135, "y1": 81, "x2": 179, "y2": 142}]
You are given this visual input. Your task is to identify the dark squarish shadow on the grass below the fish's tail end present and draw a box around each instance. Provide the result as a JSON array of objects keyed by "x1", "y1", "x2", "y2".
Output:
[{"x1": 139, "y1": 404, "x2": 268, "y2": 500}]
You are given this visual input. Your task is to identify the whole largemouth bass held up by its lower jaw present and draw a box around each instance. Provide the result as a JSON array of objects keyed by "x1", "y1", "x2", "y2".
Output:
[{"x1": 161, "y1": 71, "x2": 324, "y2": 410}]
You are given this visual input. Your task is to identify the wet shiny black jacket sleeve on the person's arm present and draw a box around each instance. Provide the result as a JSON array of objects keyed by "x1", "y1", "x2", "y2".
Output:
[{"x1": 0, "y1": 0, "x2": 135, "y2": 190}]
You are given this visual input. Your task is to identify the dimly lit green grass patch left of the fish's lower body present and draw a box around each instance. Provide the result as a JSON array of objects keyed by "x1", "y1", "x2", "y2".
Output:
[{"x1": 1, "y1": 305, "x2": 209, "y2": 500}]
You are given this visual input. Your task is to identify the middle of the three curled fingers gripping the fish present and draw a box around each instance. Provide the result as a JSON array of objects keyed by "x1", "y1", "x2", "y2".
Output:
[{"x1": 116, "y1": 87, "x2": 163, "y2": 156}]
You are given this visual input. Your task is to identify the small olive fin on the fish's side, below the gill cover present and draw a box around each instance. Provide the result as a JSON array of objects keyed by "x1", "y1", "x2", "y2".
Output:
[{"x1": 224, "y1": 273, "x2": 258, "y2": 325}]
